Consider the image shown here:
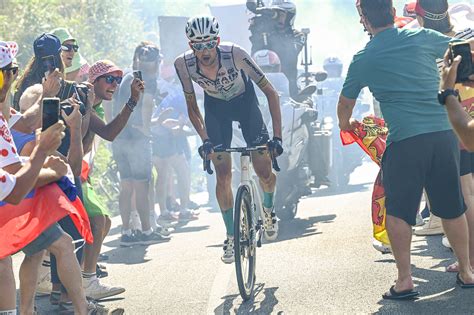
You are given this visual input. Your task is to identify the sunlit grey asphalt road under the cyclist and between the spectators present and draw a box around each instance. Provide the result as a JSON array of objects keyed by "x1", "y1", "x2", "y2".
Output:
[{"x1": 15, "y1": 163, "x2": 474, "y2": 314}]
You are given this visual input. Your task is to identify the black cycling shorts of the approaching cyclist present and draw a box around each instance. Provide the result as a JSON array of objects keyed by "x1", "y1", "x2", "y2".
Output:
[{"x1": 204, "y1": 92, "x2": 270, "y2": 148}]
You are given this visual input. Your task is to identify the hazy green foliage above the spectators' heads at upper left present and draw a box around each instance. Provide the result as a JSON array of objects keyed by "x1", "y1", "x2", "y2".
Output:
[{"x1": 0, "y1": 0, "x2": 143, "y2": 67}]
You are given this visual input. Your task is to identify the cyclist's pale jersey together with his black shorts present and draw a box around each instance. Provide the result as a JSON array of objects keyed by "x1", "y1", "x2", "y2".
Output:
[{"x1": 175, "y1": 44, "x2": 269, "y2": 148}]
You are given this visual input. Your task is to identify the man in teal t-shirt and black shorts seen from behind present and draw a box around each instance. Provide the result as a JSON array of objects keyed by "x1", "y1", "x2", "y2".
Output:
[{"x1": 338, "y1": 0, "x2": 474, "y2": 299}]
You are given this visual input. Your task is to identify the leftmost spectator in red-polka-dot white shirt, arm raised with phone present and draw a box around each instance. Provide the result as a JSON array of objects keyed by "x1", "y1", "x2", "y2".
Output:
[{"x1": 0, "y1": 42, "x2": 110, "y2": 314}]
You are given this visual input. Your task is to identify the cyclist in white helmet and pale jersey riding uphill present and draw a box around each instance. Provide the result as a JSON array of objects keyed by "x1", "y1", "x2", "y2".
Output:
[{"x1": 175, "y1": 16, "x2": 283, "y2": 263}]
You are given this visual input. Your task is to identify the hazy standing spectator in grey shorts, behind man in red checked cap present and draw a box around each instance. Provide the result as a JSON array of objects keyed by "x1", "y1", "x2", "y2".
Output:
[{"x1": 112, "y1": 42, "x2": 169, "y2": 247}]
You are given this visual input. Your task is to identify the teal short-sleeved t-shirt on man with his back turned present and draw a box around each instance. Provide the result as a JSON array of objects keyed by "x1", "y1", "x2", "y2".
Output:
[{"x1": 341, "y1": 28, "x2": 453, "y2": 144}]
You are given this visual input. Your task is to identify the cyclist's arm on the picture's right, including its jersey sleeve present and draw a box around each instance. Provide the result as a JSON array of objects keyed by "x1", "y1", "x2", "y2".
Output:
[{"x1": 232, "y1": 45, "x2": 281, "y2": 139}]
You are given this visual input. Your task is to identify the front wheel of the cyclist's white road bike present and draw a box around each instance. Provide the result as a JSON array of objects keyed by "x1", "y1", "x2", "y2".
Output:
[{"x1": 234, "y1": 186, "x2": 257, "y2": 301}]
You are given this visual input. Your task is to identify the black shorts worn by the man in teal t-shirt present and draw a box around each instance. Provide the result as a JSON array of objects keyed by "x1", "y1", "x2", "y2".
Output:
[{"x1": 382, "y1": 130, "x2": 466, "y2": 225}]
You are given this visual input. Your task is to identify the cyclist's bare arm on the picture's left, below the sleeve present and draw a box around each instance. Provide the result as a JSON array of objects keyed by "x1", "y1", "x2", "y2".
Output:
[{"x1": 174, "y1": 57, "x2": 209, "y2": 141}]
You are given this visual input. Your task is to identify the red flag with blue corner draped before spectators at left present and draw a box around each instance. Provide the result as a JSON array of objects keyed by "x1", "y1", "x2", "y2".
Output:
[{"x1": 0, "y1": 177, "x2": 93, "y2": 259}]
